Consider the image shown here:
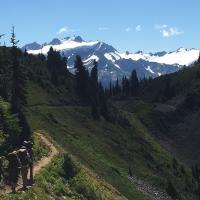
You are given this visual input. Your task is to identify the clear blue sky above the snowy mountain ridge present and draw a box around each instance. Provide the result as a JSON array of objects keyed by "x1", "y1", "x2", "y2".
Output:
[{"x1": 0, "y1": 0, "x2": 200, "y2": 52}]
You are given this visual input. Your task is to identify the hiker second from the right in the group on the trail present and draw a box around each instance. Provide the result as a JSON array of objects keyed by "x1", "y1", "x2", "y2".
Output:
[{"x1": 18, "y1": 146, "x2": 30, "y2": 190}]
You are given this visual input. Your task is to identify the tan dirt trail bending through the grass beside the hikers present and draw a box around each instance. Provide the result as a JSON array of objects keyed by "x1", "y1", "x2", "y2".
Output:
[{"x1": 0, "y1": 132, "x2": 59, "y2": 196}]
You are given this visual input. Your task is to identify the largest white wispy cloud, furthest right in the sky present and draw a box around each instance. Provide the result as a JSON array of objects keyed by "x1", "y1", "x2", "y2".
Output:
[{"x1": 154, "y1": 24, "x2": 184, "y2": 38}]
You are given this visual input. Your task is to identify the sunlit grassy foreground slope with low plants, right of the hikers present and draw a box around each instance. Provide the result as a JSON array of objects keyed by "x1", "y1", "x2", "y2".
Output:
[{"x1": 1, "y1": 153, "x2": 126, "y2": 200}]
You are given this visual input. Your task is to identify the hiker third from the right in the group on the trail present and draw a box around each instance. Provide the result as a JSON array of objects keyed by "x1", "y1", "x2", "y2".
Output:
[{"x1": 8, "y1": 151, "x2": 21, "y2": 193}]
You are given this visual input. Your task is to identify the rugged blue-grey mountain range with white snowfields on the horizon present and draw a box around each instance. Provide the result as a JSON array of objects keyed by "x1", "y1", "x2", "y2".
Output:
[{"x1": 22, "y1": 36, "x2": 199, "y2": 86}]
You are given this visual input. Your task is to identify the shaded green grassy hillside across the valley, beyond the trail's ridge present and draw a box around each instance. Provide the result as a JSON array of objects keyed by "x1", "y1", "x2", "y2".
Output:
[{"x1": 23, "y1": 83, "x2": 195, "y2": 200}]
